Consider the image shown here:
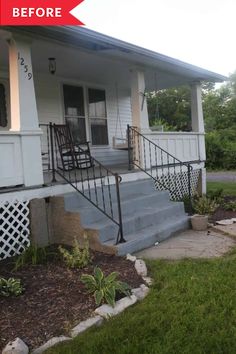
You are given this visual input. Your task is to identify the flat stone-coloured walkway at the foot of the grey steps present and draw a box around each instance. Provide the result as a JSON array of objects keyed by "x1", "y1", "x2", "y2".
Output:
[{"x1": 135, "y1": 230, "x2": 236, "y2": 259}]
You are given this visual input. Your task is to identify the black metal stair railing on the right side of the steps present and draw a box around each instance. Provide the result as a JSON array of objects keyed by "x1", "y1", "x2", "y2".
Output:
[{"x1": 127, "y1": 125, "x2": 193, "y2": 204}]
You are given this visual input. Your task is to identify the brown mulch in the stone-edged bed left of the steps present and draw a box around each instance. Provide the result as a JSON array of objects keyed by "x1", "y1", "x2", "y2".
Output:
[{"x1": 0, "y1": 252, "x2": 143, "y2": 351}]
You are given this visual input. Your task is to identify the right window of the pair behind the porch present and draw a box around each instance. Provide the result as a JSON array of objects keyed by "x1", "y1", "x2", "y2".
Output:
[{"x1": 88, "y1": 89, "x2": 108, "y2": 145}]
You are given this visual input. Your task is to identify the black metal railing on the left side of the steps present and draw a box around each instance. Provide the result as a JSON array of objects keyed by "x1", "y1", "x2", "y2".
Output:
[{"x1": 41, "y1": 123, "x2": 125, "y2": 243}]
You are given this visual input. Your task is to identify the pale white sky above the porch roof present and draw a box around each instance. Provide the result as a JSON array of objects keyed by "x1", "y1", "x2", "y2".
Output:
[{"x1": 76, "y1": 0, "x2": 236, "y2": 76}]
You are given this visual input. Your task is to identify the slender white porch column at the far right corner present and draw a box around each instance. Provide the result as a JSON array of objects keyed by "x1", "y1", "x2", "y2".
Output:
[{"x1": 191, "y1": 82, "x2": 206, "y2": 193}]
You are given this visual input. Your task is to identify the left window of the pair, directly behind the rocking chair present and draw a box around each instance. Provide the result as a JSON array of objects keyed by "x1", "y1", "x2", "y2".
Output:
[{"x1": 63, "y1": 85, "x2": 87, "y2": 144}]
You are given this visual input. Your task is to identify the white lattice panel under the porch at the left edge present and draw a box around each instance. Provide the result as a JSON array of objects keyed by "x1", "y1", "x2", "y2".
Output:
[{"x1": 0, "y1": 201, "x2": 30, "y2": 260}]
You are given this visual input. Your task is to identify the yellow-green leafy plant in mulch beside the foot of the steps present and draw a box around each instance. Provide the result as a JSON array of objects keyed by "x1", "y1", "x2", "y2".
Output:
[{"x1": 58, "y1": 237, "x2": 91, "y2": 268}]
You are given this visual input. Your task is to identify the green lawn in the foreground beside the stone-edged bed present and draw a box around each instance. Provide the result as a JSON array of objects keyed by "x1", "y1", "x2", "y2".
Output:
[{"x1": 47, "y1": 250, "x2": 236, "y2": 354}]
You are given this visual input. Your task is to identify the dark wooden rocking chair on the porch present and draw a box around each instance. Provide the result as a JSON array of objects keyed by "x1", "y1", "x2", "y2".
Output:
[{"x1": 53, "y1": 124, "x2": 93, "y2": 171}]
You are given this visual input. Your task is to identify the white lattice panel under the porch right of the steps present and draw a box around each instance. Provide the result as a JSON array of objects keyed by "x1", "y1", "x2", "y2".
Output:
[{"x1": 155, "y1": 170, "x2": 200, "y2": 200}]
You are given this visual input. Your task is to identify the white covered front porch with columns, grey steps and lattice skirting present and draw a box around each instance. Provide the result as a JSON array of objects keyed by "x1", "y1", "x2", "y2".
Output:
[{"x1": 0, "y1": 27, "x2": 227, "y2": 258}]
